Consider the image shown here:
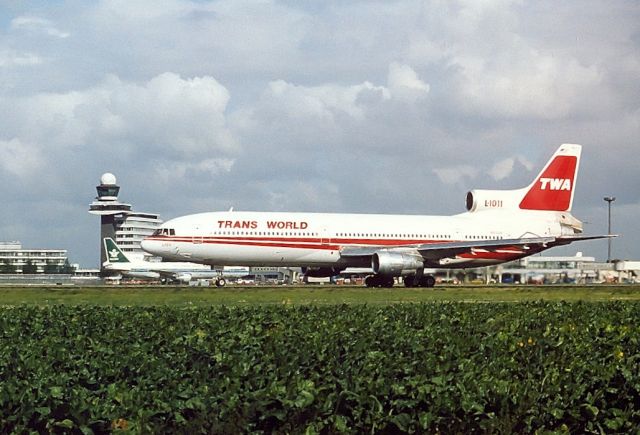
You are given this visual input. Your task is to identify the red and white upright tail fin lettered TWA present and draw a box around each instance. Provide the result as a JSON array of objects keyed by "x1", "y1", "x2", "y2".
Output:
[{"x1": 520, "y1": 144, "x2": 582, "y2": 211}]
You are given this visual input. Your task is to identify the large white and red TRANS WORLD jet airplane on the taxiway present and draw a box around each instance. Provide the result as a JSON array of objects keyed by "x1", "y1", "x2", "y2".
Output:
[{"x1": 141, "y1": 144, "x2": 611, "y2": 287}]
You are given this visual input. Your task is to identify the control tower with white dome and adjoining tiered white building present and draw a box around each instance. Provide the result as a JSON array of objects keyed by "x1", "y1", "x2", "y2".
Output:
[{"x1": 89, "y1": 172, "x2": 162, "y2": 271}]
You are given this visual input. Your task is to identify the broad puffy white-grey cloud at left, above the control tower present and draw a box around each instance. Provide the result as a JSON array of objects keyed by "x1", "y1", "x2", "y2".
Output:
[{"x1": 2, "y1": 73, "x2": 238, "y2": 158}]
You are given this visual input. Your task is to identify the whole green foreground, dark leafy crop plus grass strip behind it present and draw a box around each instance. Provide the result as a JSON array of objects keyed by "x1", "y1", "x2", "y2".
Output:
[{"x1": 0, "y1": 287, "x2": 640, "y2": 433}]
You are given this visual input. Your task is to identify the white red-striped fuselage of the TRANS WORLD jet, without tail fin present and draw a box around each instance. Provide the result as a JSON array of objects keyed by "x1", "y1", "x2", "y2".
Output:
[{"x1": 142, "y1": 210, "x2": 561, "y2": 267}]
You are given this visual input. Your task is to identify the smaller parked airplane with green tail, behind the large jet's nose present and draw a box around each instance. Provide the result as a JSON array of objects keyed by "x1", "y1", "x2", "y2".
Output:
[{"x1": 103, "y1": 237, "x2": 249, "y2": 287}]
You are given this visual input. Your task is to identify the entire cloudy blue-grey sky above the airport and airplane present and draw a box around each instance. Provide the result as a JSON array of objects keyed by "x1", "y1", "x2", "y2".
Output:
[{"x1": 0, "y1": 0, "x2": 640, "y2": 267}]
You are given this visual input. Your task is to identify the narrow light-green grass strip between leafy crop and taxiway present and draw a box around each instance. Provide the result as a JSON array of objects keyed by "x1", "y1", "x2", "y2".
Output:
[{"x1": 0, "y1": 285, "x2": 640, "y2": 305}]
